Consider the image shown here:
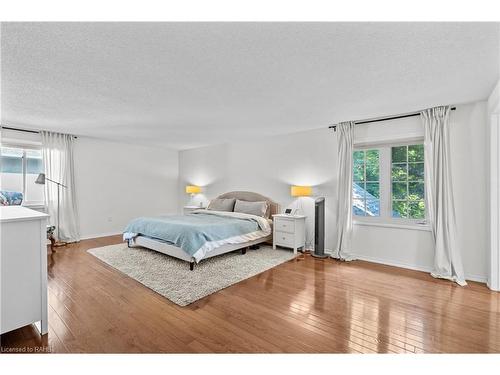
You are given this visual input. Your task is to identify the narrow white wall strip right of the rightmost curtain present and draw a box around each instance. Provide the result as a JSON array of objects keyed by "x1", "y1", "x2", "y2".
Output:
[{"x1": 451, "y1": 102, "x2": 490, "y2": 281}]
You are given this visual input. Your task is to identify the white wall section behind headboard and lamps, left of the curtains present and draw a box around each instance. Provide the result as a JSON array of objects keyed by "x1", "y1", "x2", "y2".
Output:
[{"x1": 179, "y1": 129, "x2": 336, "y2": 251}]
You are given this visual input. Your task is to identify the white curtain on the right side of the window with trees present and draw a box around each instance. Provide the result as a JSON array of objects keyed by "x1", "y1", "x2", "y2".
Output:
[{"x1": 420, "y1": 106, "x2": 467, "y2": 285}]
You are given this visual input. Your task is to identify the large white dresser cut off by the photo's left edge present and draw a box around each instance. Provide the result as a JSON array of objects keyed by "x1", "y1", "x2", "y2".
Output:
[{"x1": 0, "y1": 206, "x2": 48, "y2": 335}]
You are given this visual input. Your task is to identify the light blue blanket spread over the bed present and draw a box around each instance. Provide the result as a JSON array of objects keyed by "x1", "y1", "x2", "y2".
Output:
[{"x1": 124, "y1": 212, "x2": 261, "y2": 256}]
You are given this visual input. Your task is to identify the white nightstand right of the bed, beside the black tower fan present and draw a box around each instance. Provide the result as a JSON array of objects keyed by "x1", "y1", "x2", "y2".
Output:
[{"x1": 273, "y1": 214, "x2": 306, "y2": 254}]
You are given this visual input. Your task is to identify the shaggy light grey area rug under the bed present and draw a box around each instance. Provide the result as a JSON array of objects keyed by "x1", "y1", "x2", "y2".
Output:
[{"x1": 87, "y1": 244, "x2": 294, "y2": 306}]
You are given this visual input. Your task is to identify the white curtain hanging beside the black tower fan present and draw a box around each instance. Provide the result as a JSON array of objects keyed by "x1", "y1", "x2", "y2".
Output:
[{"x1": 332, "y1": 121, "x2": 354, "y2": 260}]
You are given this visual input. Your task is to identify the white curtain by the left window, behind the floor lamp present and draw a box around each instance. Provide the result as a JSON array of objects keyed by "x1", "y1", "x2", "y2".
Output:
[{"x1": 40, "y1": 131, "x2": 80, "y2": 242}]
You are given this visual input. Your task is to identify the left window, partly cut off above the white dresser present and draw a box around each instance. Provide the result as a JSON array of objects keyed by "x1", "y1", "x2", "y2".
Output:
[{"x1": 0, "y1": 147, "x2": 44, "y2": 205}]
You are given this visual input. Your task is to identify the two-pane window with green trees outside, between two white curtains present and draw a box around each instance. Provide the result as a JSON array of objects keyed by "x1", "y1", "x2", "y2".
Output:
[{"x1": 352, "y1": 142, "x2": 426, "y2": 224}]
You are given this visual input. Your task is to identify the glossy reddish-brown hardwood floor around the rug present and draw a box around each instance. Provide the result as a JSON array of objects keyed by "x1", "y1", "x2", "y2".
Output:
[{"x1": 0, "y1": 236, "x2": 500, "y2": 353}]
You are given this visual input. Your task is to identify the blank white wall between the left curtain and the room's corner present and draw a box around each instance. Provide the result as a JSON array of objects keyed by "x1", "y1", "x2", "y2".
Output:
[{"x1": 74, "y1": 137, "x2": 178, "y2": 238}]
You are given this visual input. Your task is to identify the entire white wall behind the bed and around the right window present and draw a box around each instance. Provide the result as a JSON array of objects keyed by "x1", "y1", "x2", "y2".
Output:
[{"x1": 178, "y1": 102, "x2": 489, "y2": 281}]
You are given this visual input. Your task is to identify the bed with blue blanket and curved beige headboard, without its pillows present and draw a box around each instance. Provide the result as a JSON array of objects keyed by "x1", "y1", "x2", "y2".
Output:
[{"x1": 124, "y1": 191, "x2": 279, "y2": 271}]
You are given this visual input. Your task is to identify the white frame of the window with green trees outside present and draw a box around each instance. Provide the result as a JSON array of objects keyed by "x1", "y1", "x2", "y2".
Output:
[{"x1": 353, "y1": 137, "x2": 430, "y2": 230}]
